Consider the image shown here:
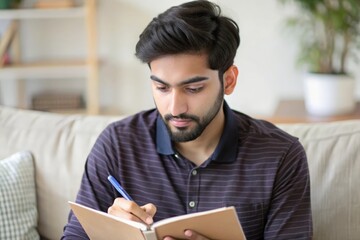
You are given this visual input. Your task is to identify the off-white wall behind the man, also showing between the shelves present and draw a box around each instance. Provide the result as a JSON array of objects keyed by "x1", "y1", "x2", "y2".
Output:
[{"x1": 0, "y1": 0, "x2": 360, "y2": 115}]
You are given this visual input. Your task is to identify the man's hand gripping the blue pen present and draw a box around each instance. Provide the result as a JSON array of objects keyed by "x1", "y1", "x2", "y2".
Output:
[{"x1": 108, "y1": 198, "x2": 156, "y2": 225}]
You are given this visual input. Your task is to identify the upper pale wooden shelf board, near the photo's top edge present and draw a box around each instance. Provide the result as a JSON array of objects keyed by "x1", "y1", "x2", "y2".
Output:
[{"x1": 0, "y1": 7, "x2": 85, "y2": 20}]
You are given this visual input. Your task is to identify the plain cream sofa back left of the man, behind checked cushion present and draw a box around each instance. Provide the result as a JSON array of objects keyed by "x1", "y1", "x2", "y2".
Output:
[{"x1": 0, "y1": 107, "x2": 121, "y2": 239}]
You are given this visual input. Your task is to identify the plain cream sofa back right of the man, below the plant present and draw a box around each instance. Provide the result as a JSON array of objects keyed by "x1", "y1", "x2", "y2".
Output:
[{"x1": 279, "y1": 120, "x2": 360, "y2": 240}]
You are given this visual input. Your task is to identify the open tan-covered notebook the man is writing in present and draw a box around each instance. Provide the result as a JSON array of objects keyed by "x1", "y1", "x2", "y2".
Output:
[{"x1": 69, "y1": 201, "x2": 246, "y2": 240}]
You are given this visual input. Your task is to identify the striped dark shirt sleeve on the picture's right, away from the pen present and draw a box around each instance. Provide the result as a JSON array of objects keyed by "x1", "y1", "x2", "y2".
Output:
[{"x1": 264, "y1": 141, "x2": 312, "y2": 240}]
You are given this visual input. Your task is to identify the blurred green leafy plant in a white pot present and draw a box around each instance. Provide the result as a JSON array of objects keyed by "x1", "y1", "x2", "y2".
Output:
[{"x1": 279, "y1": 0, "x2": 360, "y2": 115}]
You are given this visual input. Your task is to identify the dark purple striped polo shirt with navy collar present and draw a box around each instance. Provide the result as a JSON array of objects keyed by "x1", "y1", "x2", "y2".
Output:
[{"x1": 63, "y1": 102, "x2": 312, "y2": 240}]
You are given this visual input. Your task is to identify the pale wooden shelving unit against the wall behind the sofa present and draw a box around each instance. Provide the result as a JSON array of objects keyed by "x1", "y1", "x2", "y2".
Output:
[{"x1": 0, "y1": 0, "x2": 99, "y2": 114}]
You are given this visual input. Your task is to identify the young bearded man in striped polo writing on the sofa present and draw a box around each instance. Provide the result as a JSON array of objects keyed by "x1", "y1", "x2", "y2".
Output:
[{"x1": 63, "y1": 1, "x2": 312, "y2": 240}]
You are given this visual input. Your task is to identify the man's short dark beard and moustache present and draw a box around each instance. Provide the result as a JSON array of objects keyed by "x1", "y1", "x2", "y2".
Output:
[{"x1": 163, "y1": 88, "x2": 224, "y2": 142}]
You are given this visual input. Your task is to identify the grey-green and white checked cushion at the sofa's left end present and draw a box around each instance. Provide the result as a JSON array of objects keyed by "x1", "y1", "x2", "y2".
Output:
[{"x1": 0, "y1": 151, "x2": 39, "y2": 240}]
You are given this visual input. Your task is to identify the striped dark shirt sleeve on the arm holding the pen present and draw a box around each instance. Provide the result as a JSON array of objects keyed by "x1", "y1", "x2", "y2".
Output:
[{"x1": 61, "y1": 124, "x2": 116, "y2": 240}]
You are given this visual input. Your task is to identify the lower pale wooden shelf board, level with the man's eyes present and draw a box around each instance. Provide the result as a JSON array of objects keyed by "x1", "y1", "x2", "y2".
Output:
[{"x1": 0, "y1": 61, "x2": 88, "y2": 79}]
